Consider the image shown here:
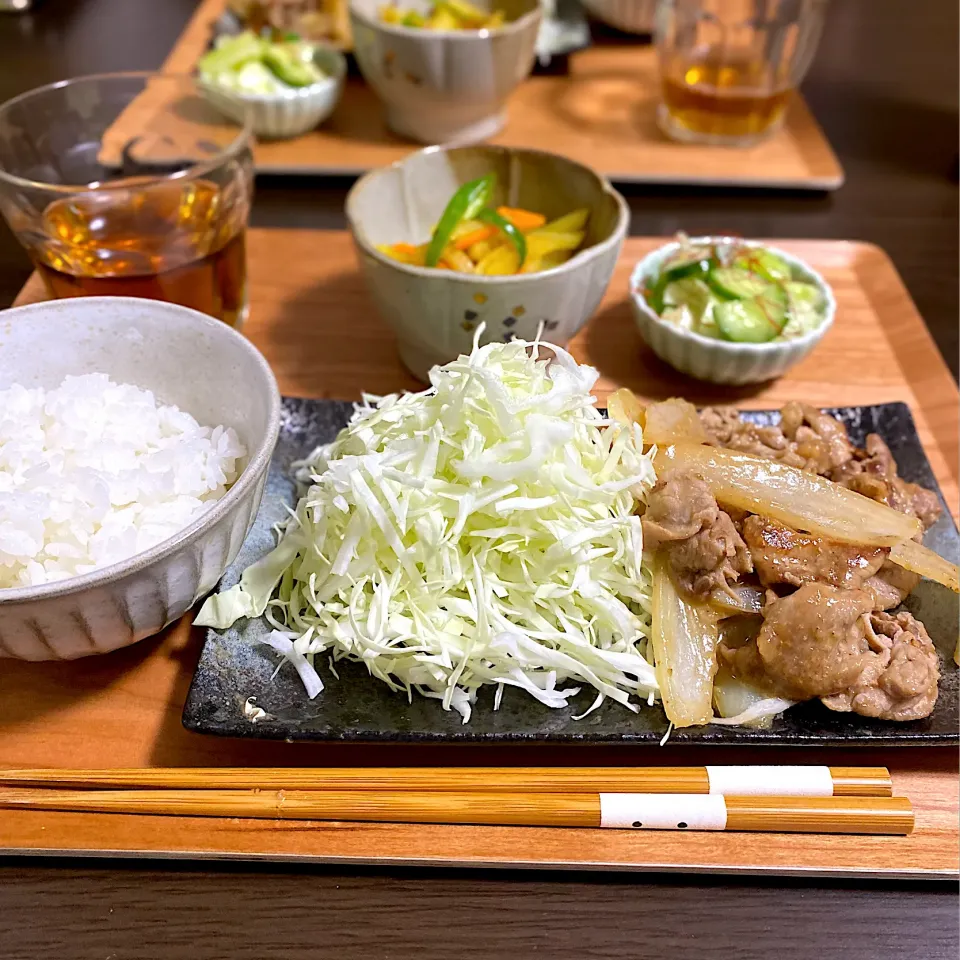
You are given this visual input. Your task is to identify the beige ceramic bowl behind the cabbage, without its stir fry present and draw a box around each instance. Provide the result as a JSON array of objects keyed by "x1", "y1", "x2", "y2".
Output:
[{"x1": 346, "y1": 146, "x2": 630, "y2": 380}]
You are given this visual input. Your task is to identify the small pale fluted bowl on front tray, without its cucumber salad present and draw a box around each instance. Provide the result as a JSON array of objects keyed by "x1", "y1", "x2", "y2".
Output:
[{"x1": 630, "y1": 237, "x2": 837, "y2": 385}]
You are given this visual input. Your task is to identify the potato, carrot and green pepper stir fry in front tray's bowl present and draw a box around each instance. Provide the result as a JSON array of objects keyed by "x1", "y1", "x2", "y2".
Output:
[{"x1": 378, "y1": 174, "x2": 589, "y2": 276}]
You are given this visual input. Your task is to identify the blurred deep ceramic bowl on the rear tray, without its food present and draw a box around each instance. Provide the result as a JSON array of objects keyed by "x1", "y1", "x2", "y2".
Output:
[{"x1": 350, "y1": 0, "x2": 541, "y2": 145}]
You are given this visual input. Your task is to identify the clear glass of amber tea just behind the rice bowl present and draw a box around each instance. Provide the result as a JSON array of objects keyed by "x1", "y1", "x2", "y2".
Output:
[{"x1": 0, "y1": 73, "x2": 253, "y2": 326}]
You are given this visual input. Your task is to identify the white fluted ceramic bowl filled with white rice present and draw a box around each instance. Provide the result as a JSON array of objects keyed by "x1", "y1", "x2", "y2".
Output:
[{"x1": 0, "y1": 297, "x2": 280, "y2": 660}]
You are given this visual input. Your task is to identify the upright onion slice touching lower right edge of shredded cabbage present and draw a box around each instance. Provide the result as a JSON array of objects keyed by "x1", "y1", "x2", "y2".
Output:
[{"x1": 650, "y1": 556, "x2": 720, "y2": 727}]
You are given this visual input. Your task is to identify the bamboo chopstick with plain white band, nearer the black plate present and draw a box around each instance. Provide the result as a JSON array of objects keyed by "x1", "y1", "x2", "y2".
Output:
[{"x1": 0, "y1": 766, "x2": 893, "y2": 797}]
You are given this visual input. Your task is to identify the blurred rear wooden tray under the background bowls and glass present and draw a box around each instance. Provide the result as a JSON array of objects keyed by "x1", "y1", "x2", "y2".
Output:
[{"x1": 163, "y1": 0, "x2": 843, "y2": 190}]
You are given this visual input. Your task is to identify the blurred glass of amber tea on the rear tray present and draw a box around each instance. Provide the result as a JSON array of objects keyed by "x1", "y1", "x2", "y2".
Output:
[{"x1": 656, "y1": 0, "x2": 827, "y2": 146}]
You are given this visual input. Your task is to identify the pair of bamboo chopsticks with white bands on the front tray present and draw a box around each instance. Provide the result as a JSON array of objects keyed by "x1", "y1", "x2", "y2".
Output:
[{"x1": 0, "y1": 766, "x2": 913, "y2": 835}]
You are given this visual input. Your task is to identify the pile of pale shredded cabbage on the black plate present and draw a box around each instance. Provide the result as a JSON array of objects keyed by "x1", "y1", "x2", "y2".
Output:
[{"x1": 197, "y1": 340, "x2": 657, "y2": 722}]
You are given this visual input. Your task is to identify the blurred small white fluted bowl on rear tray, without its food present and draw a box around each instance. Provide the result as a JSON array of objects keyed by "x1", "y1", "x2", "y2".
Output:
[{"x1": 197, "y1": 46, "x2": 347, "y2": 140}]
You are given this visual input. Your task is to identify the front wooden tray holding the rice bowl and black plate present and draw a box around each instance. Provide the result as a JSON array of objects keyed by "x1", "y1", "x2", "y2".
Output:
[{"x1": 0, "y1": 230, "x2": 960, "y2": 878}]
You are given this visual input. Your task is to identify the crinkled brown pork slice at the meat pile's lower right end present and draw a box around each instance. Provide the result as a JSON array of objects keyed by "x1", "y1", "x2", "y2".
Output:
[{"x1": 823, "y1": 612, "x2": 940, "y2": 721}]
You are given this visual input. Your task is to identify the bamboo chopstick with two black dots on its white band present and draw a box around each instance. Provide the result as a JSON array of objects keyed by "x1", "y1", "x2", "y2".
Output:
[{"x1": 0, "y1": 788, "x2": 913, "y2": 835}]
